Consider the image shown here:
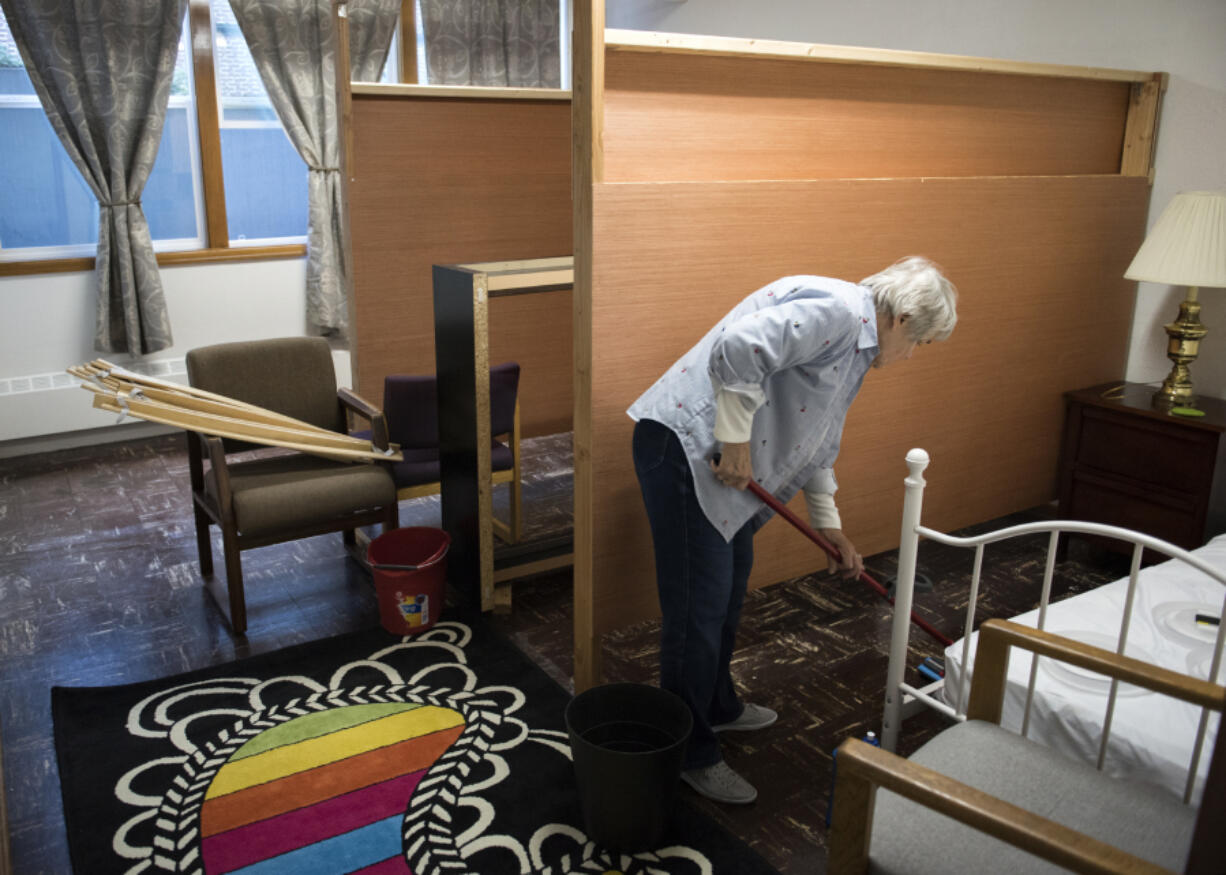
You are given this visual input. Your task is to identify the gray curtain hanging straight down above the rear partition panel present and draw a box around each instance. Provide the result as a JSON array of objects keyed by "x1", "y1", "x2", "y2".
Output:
[{"x1": 422, "y1": 0, "x2": 562, "y2": 88}]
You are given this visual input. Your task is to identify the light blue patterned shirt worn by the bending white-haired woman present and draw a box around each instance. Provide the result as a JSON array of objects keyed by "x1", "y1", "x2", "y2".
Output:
[{"x1": 626, "y1": 276, "x2": 878, "y2": 540}]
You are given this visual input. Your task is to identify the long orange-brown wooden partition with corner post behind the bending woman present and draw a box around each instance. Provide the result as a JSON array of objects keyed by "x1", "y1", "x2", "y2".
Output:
[{"x1": 574, "y1": 11, "x2": 1162, "y2": 689}]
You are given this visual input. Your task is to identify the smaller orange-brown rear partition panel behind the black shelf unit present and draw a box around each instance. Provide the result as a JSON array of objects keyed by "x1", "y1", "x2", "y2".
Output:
[{"x1": 349, "y1": 94, "x2": 571, "y2": 436}]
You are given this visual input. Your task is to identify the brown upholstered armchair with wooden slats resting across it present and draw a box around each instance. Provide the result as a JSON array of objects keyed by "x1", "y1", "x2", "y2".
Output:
[{"x1": 188, "y1": 337, "x2": 398, "y2": 634}]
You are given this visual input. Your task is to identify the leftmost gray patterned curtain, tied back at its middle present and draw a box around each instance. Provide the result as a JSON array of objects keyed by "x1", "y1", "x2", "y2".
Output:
[{"x1": 0, "y1": 0, "x2": 186, "y2": 355}]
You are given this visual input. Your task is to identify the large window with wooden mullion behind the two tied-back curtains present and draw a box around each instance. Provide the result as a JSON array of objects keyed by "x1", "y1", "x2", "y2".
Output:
[{"x1": 0, "y1": 0, "x2": 307, "y2": 268}]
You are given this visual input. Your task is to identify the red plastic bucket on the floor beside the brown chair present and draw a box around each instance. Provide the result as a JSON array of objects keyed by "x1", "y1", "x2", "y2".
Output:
[{"x1": 367, "y1": 526, "x2": 451, "y2": 635}]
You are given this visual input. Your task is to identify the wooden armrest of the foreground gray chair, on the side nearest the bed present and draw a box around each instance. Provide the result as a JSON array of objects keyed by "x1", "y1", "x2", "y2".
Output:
[{"x1": 966, "y1": 620, "x2": 1226, "y2": 724}]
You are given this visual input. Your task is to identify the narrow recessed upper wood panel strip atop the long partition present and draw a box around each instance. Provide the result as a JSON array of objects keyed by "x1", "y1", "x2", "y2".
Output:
[{"x1": 603, "y1": 48, "x2": 1132, "y2": 183}]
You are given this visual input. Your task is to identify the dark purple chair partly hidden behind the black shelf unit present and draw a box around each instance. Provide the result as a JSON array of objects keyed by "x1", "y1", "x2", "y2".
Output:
[{"x1": 383, "y1": 362, "x2": 522, "y2": 544}]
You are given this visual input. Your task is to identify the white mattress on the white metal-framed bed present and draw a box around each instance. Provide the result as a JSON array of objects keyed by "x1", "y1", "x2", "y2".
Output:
[{"x1": 944, "y1": 534, "x2": 1226, "y2": 801}]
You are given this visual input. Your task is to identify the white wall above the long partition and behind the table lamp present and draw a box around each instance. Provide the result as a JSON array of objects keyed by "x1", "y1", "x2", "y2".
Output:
[{"x1": 606, "y1": 0, "x2": 1226, "y2": 398}]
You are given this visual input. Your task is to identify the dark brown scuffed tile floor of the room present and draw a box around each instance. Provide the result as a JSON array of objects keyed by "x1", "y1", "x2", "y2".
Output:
[{"x1": 0, "y1": 435, "x2": 1119, "y2": 875}]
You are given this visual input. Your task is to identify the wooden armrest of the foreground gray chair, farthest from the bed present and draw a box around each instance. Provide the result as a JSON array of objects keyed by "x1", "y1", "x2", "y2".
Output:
[{"x1": 829, "y1": 739, "x2": 1170, "y2": 875}]
